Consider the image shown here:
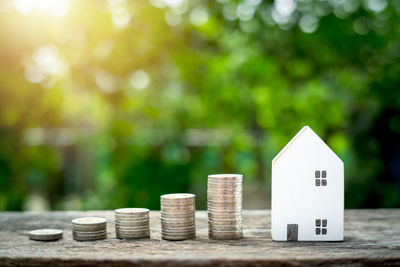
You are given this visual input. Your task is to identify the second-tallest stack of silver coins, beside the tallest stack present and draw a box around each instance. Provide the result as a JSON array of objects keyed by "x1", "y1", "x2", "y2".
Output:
[{"x1": 161, "y1": 194, "x2": 196, "y2": 240}]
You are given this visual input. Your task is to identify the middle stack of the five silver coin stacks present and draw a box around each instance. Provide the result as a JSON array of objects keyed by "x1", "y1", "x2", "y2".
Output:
[{"x1": 114, "y1": 208, "x2": 150, "y2": 239}]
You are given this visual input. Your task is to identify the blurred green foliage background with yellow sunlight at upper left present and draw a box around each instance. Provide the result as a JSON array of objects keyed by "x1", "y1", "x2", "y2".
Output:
[{"x1": 0, "y1": 0, "x2": 400, "y2": 210}]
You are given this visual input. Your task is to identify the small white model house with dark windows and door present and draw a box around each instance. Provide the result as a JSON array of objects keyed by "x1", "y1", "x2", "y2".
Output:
[{"x1": 271, "y1": 126, "x2": 344, "y2": 241}]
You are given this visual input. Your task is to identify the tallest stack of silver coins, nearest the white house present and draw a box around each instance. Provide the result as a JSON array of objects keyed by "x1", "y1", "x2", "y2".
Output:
[{"x1": 207, "y1": 174, "x2": 243, "y2": 239}]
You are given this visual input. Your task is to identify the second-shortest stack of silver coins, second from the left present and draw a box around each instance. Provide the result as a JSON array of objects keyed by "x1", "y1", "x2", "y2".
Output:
[{"x1": 72, "y1": 217, "x2": 107, "y2": 241}]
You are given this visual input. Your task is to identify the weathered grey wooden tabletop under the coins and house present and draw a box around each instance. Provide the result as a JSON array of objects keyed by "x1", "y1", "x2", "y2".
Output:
[{"x1": 0, "y1": 210, "x2": 400, "y2": 266}]
